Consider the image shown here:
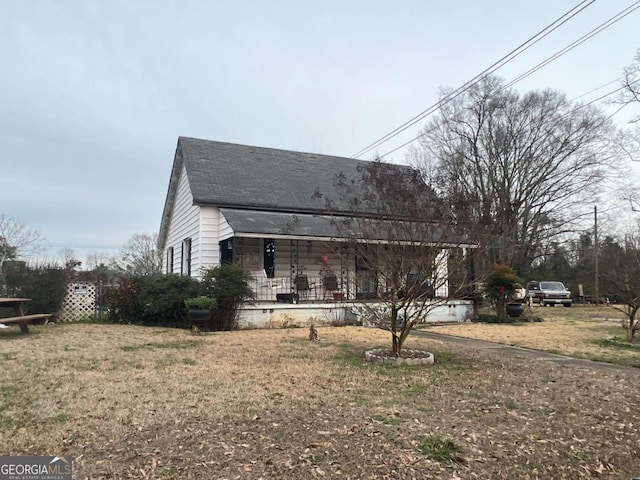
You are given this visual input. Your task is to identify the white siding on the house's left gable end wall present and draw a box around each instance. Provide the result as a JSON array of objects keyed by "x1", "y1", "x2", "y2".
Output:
[{"x1": 163, "y1": 167, "x2": 200, "y2": 276}]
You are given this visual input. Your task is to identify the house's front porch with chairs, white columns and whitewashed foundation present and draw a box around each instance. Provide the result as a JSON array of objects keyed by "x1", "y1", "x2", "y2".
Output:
[{"x1": 219, "y1": 218, "x2": 473, "y2": 328}]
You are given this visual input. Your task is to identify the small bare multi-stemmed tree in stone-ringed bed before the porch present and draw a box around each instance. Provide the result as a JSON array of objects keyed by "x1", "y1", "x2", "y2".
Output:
[{"x1": 319, "y1": 161, "x2": 474, "y2": 356}]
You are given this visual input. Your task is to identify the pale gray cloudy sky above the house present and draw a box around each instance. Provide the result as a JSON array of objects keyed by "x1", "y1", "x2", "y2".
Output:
[{"x1": 0, "y1": 0, "x2": 640, "y2": 259}]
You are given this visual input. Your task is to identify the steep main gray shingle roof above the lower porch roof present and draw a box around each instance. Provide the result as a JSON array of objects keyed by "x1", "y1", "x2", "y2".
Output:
[{"x1": 178, "y1": 137, "x2": 390, "y2": 212}]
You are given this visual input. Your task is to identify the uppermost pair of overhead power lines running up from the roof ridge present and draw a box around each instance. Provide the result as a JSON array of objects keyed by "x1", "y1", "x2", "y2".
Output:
[{"x1": 352, "y1": 0, "x2": 595, "y2": 158}]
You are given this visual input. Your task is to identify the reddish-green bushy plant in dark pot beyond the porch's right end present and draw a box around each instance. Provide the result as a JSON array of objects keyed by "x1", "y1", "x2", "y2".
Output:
[{"x1": 484, "y1": 263, "x2": 523, "y2": 318}]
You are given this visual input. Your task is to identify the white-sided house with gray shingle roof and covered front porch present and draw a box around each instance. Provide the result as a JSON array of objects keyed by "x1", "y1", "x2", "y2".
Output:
[{"x1": 158, "y1": 137, "x2": 472, "y2": 326}]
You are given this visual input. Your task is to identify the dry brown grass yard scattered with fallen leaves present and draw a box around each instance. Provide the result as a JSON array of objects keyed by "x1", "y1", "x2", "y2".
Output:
[{"x1": 0, "y1": 308, "x2": 640, "y2": 479}]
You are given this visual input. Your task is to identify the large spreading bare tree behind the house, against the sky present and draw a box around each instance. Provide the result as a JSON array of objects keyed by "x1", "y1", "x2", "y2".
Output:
[{"x1": 413, "y1": 77, "x2": 620, "y2": 274}]
